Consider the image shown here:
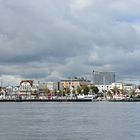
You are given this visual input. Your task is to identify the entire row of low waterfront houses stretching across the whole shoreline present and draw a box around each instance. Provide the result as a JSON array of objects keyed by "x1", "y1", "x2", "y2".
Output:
[{"x1": 0, "y1": 77, "x2": 140, "y2": 98}]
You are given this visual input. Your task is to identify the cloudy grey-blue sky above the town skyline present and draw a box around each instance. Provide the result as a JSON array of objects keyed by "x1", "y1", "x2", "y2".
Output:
[{"x1": 0, "y1": 0, "x2": 140, "y2": 85}]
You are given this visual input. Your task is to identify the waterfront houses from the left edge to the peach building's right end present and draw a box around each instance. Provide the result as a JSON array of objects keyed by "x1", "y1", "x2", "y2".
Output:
[{"x1": 0, "y1": 78, "x2": 91, "y2": 98}]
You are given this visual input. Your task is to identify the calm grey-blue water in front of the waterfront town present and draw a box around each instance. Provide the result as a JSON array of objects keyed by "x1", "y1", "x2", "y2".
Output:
[{"x1": 0, "y1": 102, "x2": 140, "y2": 140}]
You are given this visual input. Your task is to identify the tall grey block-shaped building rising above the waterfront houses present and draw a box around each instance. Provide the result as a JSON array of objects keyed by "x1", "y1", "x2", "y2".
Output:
[{"x1": 93, "y1": 71, "x2": 115, "y2": 85}]
